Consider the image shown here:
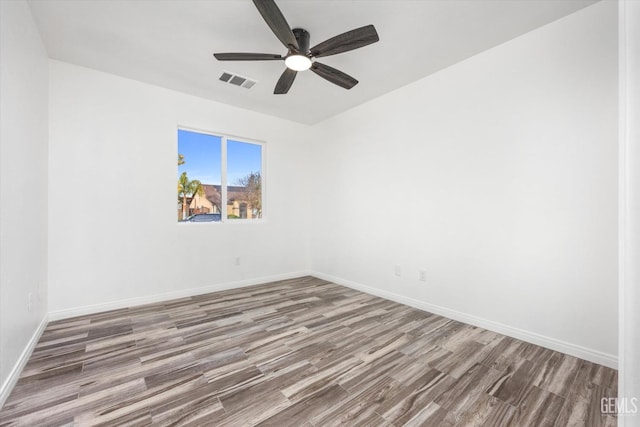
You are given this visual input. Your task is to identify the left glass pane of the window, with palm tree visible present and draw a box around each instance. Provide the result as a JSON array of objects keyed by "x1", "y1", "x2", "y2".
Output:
[{"x1": 178, "y1": 129, "x2": 222, "y2": 222}]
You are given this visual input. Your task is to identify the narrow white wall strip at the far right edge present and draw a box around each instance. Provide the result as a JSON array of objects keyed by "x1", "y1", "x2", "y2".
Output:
[{"x1": 618, "y1": 0, "x2": 640, "y2": 426}]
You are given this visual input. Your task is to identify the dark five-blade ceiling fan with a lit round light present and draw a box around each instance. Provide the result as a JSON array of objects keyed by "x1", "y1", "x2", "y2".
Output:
[{"x1": 213, "y1": 0, "x2": 379, "y2": 95}]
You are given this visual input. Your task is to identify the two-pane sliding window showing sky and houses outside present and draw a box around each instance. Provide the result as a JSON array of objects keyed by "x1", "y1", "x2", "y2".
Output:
[{"x1": 177, "y1": 129, "x2": 264, "y2": 222}]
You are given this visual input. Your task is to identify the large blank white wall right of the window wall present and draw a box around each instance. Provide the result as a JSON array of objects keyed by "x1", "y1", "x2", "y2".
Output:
[{"x1": 311, "y1": 2, "x2": 617, "y2": 365}]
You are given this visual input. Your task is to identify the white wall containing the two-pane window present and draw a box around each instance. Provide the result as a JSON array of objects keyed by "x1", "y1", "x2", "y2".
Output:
[{"x1": 49, "y1": 61, "x2": 309, "y2": 318}]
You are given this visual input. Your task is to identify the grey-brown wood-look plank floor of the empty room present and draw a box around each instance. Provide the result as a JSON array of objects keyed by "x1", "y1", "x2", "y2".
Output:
[{"x1": 0, "y1": 277, "x2": 617, "y2": 427}]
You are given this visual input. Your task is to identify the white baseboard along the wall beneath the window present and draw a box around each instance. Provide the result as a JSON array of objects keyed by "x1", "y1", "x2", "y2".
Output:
[{"x1": 49, "y1": 271, "x2": 309, "y2": 321}]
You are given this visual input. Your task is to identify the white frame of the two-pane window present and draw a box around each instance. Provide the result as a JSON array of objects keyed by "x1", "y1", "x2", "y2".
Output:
[{"x1": 178, "y1": 126, "x2": 268, "y2": 225}]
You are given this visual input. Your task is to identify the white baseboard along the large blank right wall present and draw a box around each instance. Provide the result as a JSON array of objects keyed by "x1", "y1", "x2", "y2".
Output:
[{"x1": 309, "y1": 271, "x2": 618, "y2": 369}]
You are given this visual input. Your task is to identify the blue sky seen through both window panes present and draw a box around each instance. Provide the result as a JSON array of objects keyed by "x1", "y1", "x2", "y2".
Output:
[{"x1": 178, "y1": 129, "x2": 262, "y2": 185}]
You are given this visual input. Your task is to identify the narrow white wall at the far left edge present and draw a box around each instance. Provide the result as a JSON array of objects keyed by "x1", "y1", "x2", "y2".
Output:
[{"x1": 0, "y1": 1, "x2": 49, "y2": 406}]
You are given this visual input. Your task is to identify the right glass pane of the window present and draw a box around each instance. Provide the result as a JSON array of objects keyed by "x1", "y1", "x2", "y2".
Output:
[{"x1": 227, "y1": 140, "x2": 262, "y2": 219}]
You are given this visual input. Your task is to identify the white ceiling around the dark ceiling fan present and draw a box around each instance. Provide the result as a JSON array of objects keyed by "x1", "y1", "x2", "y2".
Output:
[{"x1": 29, "y1": 0, "x2": 596, "y2": 124}]
